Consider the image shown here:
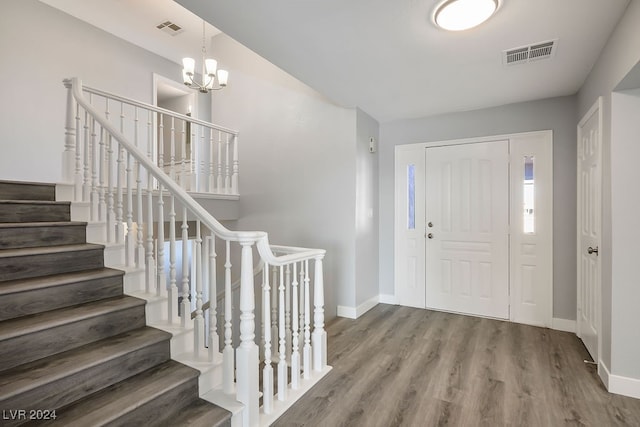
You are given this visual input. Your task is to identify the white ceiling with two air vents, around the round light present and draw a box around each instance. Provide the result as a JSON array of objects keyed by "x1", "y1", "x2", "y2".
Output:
[{"x1": 41, "y1": 0, "x2": 629, "y2": 122}]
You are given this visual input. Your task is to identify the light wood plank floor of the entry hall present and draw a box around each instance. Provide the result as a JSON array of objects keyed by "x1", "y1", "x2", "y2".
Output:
[{"x1": 274, "y1": 304, "x2": 640, "y2": 427}]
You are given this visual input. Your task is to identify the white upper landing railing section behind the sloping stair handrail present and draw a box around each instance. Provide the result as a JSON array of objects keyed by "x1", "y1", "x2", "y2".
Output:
[{"x1": 69, "y1": 80, "x2": 239, "y2": 196}]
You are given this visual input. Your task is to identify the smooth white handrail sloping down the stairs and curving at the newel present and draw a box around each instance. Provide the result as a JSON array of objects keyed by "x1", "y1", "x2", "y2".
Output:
[{"x1": 64, "y1": 77, "x2": 326, "y2": 266}]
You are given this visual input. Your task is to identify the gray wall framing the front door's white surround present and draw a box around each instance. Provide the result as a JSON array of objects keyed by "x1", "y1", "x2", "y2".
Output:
[{"x1": 380, "y1": 97, "x2": 577, "y2": 320}]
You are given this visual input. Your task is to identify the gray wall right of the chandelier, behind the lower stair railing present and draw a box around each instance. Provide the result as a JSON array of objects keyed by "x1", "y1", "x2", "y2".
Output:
[{"x1": 212, "y1": 35, "x2": 356, "y2": 318}]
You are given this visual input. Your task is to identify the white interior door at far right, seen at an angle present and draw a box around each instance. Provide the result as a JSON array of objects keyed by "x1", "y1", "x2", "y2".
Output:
[{"x1": 577, "y1": 99, "x2": 602, "y2": 362}]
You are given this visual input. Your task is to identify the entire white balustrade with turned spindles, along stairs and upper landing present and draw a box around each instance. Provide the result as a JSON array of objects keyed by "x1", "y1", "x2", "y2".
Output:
[{"x1": 63, "y1": 78, "x2": 328, "y2": 427}]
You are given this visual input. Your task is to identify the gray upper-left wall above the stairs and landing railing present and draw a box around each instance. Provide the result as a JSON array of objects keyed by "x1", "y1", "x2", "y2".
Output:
[{"x1": 0, "y1": 0, "x2": 181, "y2": 182}]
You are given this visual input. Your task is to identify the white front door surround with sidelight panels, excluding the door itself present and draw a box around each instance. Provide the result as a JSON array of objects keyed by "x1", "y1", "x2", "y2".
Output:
[{"x1": 394, "y1": 131, "x2": 553, "y2": 327}]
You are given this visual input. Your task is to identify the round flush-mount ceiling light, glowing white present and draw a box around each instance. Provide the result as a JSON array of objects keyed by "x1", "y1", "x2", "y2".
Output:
[{"x1": 433, "y1": 0, "x2": 498, "y2": 31}]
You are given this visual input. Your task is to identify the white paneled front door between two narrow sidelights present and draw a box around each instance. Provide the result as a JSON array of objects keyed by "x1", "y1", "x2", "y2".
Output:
[{"x1": 425, "y1": 140, "x2": 509, "y2": 319}]
